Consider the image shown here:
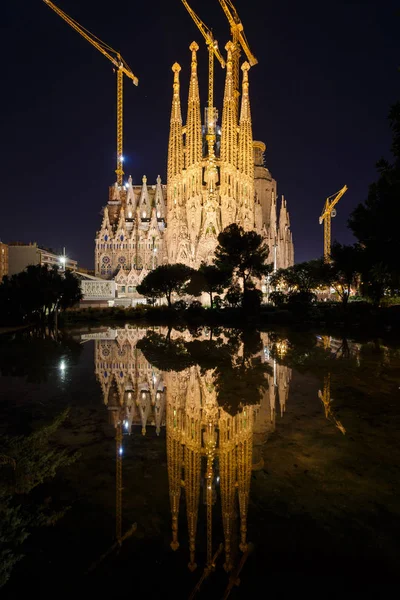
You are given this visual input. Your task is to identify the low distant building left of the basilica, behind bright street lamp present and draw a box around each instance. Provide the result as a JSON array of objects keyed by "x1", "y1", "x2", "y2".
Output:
[{"x1": 8, "y1": 242, "x2": 78, "y2": 275}]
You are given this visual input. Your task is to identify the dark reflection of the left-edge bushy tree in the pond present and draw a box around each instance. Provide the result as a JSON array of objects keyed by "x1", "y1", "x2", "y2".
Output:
[{"x1": 0, "y1": 328, "x2": 82, "y2": 383}]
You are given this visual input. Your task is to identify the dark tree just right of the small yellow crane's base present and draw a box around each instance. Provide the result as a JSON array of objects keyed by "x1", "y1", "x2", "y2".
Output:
[{"x1": 322, "y1": 242, "x2": 362, "y2": 307}]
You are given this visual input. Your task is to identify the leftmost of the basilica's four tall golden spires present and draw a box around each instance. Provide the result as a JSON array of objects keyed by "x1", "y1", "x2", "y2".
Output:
[{"x1": 168, "y1": 63, "x2": 183, "y2": 191}]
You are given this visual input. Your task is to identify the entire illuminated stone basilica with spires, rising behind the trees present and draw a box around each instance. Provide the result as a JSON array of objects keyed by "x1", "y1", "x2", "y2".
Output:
[{"x1": 95, "y1": 42, "x2": 294, "y2": 292}]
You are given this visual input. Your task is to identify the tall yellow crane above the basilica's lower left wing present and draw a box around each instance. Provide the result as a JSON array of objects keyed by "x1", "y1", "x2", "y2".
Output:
[{"x1": 43, "y1": 0, "x2": 139, "y2": 186}]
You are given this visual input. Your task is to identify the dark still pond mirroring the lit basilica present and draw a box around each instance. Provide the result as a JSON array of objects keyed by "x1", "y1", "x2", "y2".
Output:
[{"x1": 0, "y1": 325, "x2": 400, "y2": 598}]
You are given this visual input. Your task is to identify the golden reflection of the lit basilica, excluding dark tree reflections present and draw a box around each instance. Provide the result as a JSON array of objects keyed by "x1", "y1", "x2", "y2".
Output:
[{"x1": 82, "y1": 327, "x2": 291, "y2": 571}]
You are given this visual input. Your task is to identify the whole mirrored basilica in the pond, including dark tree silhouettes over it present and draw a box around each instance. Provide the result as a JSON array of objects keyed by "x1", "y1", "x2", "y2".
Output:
[{"x1": 90, "y1": 326, "x2": 290, "y2": 592}]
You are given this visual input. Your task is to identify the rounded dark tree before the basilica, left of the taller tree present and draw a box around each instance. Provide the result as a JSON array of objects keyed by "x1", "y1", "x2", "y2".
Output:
[{"x1": 137, "y1": 263, "x2": 193, "y2": 306}]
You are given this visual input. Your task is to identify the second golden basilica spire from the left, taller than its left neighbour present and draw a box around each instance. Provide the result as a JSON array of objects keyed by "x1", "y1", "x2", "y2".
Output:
[{"x1": 186, "y1": 42, "x2": 202, "y2": 168}]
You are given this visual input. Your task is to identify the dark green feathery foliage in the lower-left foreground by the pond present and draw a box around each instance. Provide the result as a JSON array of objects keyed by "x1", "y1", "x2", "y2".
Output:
[{"x1": 0, "y1": 411, "x2": 77, "y2": 587}]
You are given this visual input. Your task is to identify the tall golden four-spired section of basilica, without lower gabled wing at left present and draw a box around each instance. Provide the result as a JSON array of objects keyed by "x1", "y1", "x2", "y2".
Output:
[{"x1": 166, "y1": 42, "x2": 294, "y2": 268}]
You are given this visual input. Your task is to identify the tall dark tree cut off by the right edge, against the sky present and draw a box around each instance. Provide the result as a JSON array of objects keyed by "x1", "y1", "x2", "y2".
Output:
[{"x1": 348, "y1": 102, "x2": 400, "y2": 304}]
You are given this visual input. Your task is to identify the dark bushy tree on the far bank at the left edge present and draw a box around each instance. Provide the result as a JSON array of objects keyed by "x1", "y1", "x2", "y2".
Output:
[{"x1": 0, "y1": 265, "x2": 82, "y2": 323}]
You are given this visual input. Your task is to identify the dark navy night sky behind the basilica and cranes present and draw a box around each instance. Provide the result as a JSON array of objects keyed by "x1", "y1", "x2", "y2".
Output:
[{"x1": 0, "y1": 0, "x2": 400, "y2": 268}]
